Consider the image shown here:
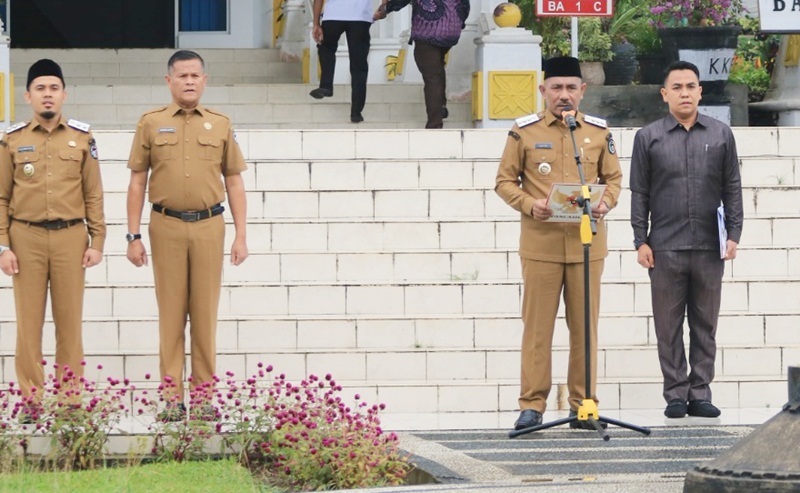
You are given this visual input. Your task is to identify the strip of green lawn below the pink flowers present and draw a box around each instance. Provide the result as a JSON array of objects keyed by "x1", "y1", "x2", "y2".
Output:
[{"x1": 0, "y1": 460, "x2": 277, "y2": 493}]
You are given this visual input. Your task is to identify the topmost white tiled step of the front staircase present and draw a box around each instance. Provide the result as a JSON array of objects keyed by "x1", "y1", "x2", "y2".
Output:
[{"x1": 89, "y1": 128, "x2": 800, "y2": 162}]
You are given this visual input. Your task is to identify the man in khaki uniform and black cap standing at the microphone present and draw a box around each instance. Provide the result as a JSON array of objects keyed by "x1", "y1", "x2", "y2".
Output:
[{"x1": 495, "y1": 57, "x2": 622, "y2": 430}]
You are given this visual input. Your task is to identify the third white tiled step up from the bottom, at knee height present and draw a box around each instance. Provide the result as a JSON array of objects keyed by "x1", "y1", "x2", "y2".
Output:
[{"x1": 0, "y1": 307, "x2": 800, "y2": 354}]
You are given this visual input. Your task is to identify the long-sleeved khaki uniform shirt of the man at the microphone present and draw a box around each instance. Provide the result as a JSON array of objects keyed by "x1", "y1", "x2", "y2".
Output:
[{"x1": 495, "y1": 111, "x2": 622, "y2": 263}]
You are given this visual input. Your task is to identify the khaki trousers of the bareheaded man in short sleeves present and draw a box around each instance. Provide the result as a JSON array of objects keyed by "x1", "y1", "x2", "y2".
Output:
[{"x1": 148, "y1": 212, "x2": 225, "y2": 396}]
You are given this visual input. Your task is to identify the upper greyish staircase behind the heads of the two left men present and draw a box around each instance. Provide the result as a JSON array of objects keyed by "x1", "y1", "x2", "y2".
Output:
[{"x1": 11, "y1": 49, "x2": 473, "y2": 130}]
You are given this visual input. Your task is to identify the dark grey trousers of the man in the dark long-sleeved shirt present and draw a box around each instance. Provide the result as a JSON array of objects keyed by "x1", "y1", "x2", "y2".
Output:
[{"x1": 650, "y1": 251, "x2": 725, "y2": 402}]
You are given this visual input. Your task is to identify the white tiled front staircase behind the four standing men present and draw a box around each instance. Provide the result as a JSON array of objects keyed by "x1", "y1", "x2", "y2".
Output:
[{"x1": 0, "y1": 128, "x2": 800, "y2": 429}]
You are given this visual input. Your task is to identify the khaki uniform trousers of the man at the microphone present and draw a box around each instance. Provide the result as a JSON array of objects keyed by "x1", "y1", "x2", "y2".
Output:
[{"x1": 519, "y1": 258, "x2": 605, "y2": 413}]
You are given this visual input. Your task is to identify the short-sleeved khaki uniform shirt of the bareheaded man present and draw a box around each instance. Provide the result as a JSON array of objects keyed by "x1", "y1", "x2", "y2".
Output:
[{"x1": 128, "y1": 103, "x2": 247, "y2": 211}]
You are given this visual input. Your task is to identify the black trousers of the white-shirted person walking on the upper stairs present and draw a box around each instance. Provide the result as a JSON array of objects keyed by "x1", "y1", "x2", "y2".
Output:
[{"x1": 317, "y1": 21, "x2": 372, "y2": 116}]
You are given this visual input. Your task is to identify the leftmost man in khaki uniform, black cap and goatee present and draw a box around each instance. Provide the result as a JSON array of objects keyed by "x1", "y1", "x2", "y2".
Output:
[{"x1": 0, "y1": 59, "x2": 106, "y2": 404}]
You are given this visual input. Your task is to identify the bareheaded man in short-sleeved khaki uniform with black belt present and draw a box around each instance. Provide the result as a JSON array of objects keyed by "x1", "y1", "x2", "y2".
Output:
[{"x1": 127, "y1": 50, "x2": 248, "y2": 420}]
